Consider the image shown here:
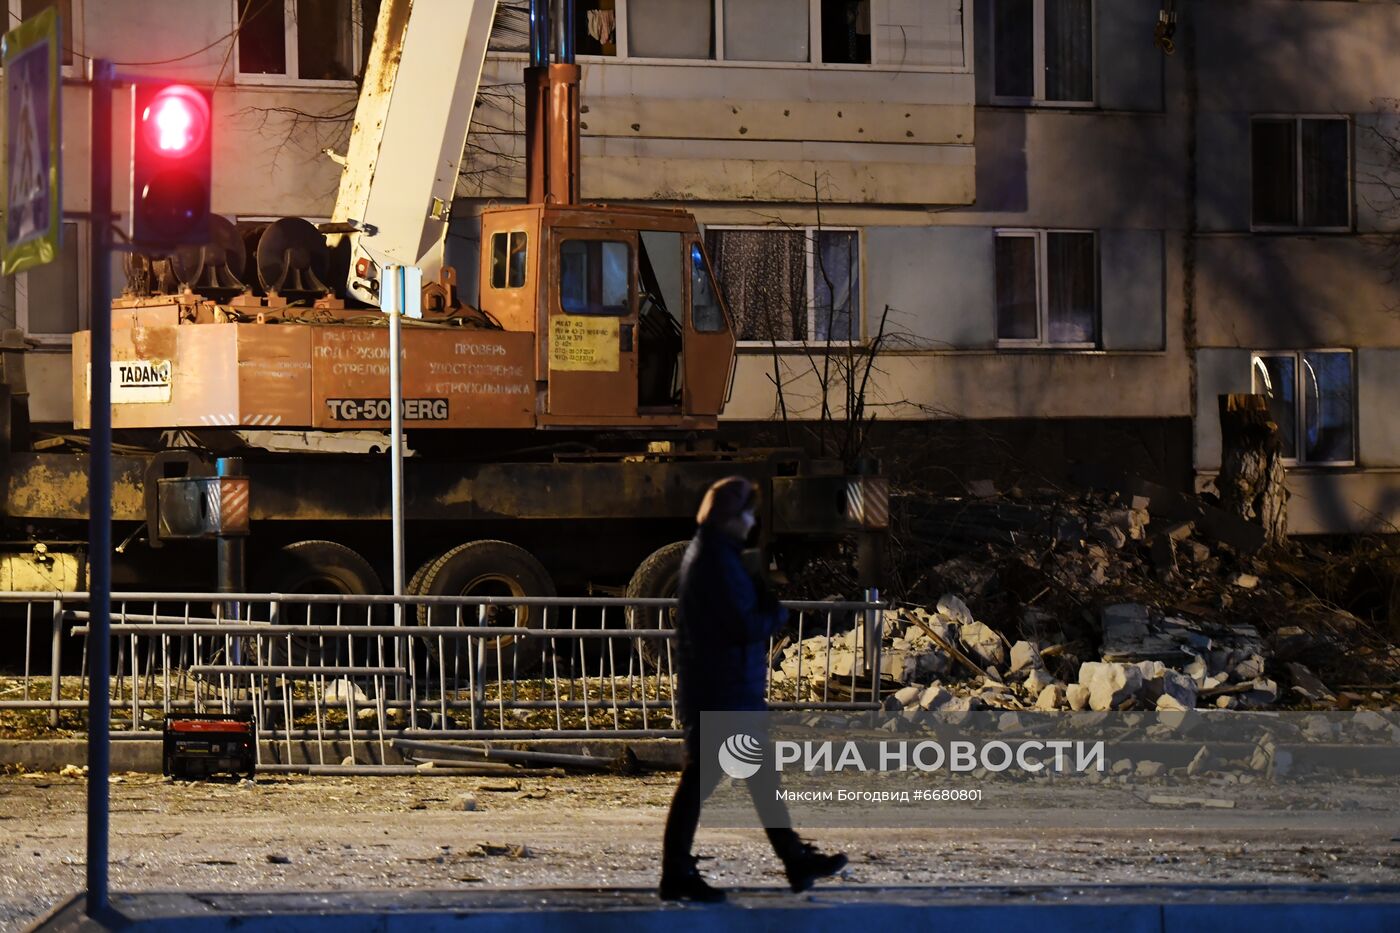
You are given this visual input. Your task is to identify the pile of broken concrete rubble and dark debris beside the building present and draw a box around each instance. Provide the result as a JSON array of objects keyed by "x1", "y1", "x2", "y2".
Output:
[{"x1": 773, "y1": 483, "x2": 1400, "y2": 710}]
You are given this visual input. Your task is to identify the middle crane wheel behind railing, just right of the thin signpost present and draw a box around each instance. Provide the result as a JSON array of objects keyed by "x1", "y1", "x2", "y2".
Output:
[{"x1": 419, "y1": 541, "x2": 556, "y2": 682}]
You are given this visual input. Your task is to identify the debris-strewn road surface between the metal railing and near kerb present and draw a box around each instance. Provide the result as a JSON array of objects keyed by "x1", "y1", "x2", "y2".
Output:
[{"x1": 0, "y1": 773, "x2": 1400, "y2": 933}]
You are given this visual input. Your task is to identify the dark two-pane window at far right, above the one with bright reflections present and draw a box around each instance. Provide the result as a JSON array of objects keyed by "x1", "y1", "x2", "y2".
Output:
[{"x1": 1250, "y1": 116, "x2": 1351, "y2": 230}]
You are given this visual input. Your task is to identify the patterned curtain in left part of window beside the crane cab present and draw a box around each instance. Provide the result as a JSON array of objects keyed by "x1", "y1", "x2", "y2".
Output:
[{"x1": 706, "y1": 230, "x2": 808, "y2": 342}]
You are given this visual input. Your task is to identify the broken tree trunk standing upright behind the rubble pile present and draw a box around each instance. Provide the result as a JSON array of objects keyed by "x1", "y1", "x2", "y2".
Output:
[{"x1": 1215, "y1": 394, "x2": 1288, "y2": 548}]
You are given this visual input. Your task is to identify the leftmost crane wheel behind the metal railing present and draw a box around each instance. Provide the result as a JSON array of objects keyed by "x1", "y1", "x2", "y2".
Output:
[{"x1": 253, "y1": 541, "x2": 384, "y2": 665}]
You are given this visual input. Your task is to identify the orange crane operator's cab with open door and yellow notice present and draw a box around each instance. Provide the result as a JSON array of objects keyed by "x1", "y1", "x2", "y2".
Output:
[{"x1": 479, "y1": 205, "x2": 735, "y2": 429}]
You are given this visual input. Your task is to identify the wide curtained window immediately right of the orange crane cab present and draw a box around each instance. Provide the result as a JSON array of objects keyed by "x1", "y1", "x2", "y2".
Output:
[{"x1": 706, "y1": 228, "x2": 861, "y2": 343}]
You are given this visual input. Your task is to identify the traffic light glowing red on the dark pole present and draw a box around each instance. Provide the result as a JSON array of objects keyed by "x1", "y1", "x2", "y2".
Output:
[{"x1": 132, "y1": 83, "x2": 213, "y2": 247}]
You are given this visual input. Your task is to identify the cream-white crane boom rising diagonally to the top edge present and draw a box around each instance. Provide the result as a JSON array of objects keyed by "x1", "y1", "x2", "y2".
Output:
[{"x1": 332, "y1": 0, "x2": 497, "y2": 305}]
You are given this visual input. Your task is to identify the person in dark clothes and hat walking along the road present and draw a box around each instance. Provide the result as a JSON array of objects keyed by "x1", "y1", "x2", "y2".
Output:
[{"x1": 659, "y1": 476, "x2": 846, "y2": 902}]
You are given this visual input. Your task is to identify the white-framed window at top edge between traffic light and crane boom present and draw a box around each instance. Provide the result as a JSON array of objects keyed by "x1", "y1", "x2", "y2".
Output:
[{"x1": 235, "y1": 0, "x2": 381, "y2": 81}]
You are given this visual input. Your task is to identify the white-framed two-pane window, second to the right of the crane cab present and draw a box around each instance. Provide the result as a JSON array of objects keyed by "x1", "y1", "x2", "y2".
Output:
[{"x1": 995, "y1": 230, "x2": 1099, "y2": 347}]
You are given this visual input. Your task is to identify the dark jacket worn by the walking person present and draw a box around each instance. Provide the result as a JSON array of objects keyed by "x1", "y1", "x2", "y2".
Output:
[{"x1": 676, "y1": 525, "x2": 787, "y2": 726}]
